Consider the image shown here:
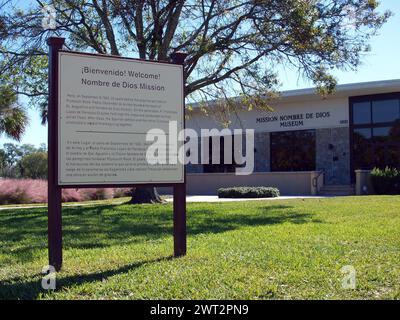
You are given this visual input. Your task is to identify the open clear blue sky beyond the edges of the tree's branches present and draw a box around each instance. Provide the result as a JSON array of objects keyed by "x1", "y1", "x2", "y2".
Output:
[{"x1": 0, "y1": 0, "x2": 400, "y2": 146}]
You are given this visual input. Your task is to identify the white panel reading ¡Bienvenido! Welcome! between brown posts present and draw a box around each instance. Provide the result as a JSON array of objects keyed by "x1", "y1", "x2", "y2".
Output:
[{"x1": 58, "y1": 51, "x2": 184, "y2": 185}]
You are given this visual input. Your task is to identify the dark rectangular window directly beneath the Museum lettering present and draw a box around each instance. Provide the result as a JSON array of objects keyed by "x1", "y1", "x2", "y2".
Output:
[{"x1": 271, "y1": 130, "x2": 316, "y2": 171}]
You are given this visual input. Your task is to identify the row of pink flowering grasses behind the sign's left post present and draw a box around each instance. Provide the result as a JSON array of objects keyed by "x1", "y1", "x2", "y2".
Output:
[{"x1": 0, "y1": 179, "x2": 130, "y2": 204}]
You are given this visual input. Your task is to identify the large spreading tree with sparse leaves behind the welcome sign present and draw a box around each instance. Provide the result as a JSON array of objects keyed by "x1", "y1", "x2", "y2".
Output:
[{"x1": 0, "y1": 0, "x2": 390, "y2": 201}]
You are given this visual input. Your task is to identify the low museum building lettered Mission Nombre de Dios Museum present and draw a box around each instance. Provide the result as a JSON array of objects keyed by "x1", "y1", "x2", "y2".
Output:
[{"x1": 186, "y1": 80, "x2": 400, "y2": 195}]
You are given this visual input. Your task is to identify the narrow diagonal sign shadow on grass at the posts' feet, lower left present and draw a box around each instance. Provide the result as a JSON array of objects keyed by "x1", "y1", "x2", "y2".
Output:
[{"x1": 0, "y1": 257, "x2": 173, "y2": 300}]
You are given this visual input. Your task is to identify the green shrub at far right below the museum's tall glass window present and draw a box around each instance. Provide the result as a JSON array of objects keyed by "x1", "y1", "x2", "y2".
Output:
[{"x1": 371, "y1": 167, "x2": 400, "y2": 195}]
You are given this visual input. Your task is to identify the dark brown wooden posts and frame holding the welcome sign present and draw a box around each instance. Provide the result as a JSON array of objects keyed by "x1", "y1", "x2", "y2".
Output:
[{"x1": 47, "y1": 37, "x2": 186, "y2": 271}]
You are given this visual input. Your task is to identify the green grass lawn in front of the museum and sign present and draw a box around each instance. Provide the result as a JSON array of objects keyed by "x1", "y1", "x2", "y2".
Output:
[{"x1": 0, "y1": 196, "x2": 400, "y2": 299}]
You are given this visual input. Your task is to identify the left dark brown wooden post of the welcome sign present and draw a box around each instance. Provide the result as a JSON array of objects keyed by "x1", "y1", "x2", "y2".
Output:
[{"x1": 47, "y1": 37, "x2": 65, "y2": 271}]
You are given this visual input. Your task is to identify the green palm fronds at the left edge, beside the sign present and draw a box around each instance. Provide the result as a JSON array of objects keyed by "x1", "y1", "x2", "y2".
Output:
[{"x1": 0, "y1": 87, "x2": 29, "y2": 141}]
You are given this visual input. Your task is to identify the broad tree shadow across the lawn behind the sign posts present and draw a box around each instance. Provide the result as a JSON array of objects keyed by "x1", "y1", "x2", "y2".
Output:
[{"x1": 0, "y1": 204, "x2": 320, "y2": 262}]
